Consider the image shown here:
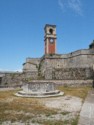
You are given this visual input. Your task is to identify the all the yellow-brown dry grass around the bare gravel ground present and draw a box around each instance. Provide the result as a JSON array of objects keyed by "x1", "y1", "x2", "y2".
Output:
[{"x1": 0, "y1": 86, "x2": 91, "y2": 125}]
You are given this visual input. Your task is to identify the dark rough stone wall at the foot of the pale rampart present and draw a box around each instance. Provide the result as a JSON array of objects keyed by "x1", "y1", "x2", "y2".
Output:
[{"x1": 45, "y1": 68, "x2": 93, "y2": 80}]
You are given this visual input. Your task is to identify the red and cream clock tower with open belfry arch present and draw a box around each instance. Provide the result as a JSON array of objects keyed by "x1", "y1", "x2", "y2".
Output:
[{"x1": 44, "y1": 24, "x2": 57, "y2": 54}]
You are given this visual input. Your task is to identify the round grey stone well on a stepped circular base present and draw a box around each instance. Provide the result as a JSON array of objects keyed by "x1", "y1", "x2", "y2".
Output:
[{"x1": 15, "y1": 82, "x2": 64, "y2": 97}]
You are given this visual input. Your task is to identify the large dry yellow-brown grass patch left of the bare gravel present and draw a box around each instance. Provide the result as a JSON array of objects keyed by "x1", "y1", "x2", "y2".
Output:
[{"x1": 0, "y1": 90, "x2": 57, "y2": 122}]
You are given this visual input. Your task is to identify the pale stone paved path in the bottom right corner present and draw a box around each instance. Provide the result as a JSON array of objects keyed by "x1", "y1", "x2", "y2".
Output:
[{"x1": 78, "y1": 89, "x2": 94, "y2": 125}]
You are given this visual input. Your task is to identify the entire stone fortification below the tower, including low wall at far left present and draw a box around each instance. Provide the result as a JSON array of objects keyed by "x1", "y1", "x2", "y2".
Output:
[{"x1": 0, "y1": 49, "x2": 94, "y2": 85}]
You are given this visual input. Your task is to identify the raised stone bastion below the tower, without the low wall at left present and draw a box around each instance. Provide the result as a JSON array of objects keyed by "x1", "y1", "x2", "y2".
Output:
[{"x1": 23, "y1": 49, "x2": 94, "y2": 79}]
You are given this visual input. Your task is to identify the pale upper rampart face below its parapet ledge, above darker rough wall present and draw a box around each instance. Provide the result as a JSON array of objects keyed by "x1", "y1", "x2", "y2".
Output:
[{"x1": 41, "y1": 55, "x2": 94, "y2": 72}]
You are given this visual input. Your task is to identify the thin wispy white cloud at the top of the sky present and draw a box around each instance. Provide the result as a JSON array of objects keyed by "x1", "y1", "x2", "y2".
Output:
[{"x1": 58, "y1": 0, "x2": 83, "y2": 16}]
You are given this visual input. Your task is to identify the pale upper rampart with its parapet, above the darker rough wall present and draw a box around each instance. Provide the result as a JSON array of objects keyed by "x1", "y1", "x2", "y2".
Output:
[{"x1": 40, "y1": 49, "x2": 94, "y2": 76}]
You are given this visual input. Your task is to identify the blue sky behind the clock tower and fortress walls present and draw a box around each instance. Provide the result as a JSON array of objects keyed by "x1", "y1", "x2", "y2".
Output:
[{"x1": 0, "y1": 0, "x2": 94, "y2": 71}]
